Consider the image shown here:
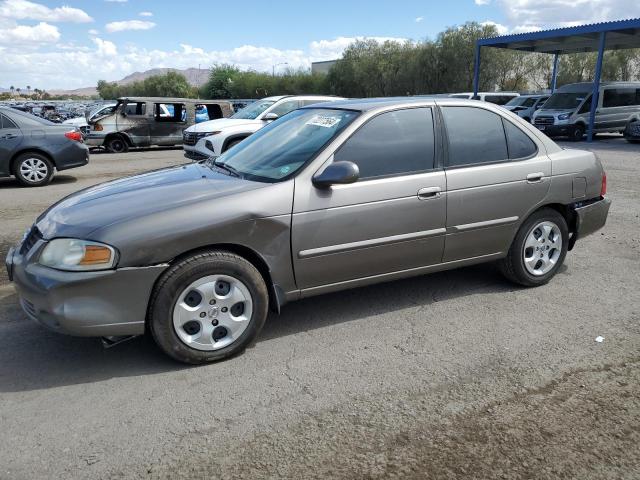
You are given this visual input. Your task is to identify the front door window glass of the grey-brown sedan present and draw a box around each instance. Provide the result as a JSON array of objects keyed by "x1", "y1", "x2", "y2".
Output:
[{"x1": 333, "y1": 108, "x2": 435, "y2": 180}]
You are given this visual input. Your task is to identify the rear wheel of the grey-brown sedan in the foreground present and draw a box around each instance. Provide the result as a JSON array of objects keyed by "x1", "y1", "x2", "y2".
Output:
[{"x1": 499, "y1": 208, "x2": 569, "y2": 287}]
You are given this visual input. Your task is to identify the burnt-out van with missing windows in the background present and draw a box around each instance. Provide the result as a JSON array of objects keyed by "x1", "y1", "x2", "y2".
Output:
[{"x1": 86, "y1": 97, "x2": 233, "y2": 153}]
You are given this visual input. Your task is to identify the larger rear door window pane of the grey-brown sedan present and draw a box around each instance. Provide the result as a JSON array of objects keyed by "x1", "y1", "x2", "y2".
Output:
[{"x1": 442, "y1": 107, "x2": 509, "y2": 167}]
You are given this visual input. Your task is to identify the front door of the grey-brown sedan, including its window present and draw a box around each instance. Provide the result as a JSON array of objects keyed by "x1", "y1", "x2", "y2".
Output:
[{"x1": 292, "y1": 108, "x2": 446, "y2": 290}]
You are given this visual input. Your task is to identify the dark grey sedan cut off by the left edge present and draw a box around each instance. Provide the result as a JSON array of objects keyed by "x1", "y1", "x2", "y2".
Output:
[{"x1": 0, "y1": 107, "x2": 89, "y2": 187}]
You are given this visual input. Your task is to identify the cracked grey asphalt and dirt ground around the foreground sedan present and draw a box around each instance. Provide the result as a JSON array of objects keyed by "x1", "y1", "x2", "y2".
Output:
[{"x1": 0, "y1": 138, "x2": 640, "y2": 479}]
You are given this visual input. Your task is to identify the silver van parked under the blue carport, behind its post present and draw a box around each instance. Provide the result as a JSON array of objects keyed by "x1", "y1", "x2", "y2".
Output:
[{"x1": 533, "y1": 82, "x2": 640, "y2": 141}]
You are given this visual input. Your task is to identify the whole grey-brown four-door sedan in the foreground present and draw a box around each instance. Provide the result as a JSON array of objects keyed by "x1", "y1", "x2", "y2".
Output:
[{"x1": 7, "y1": 99, "x2": 610, "y2": 363}]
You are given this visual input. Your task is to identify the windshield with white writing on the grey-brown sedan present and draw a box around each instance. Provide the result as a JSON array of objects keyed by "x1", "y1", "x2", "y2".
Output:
[{"x1": 208, "y1": 109, "x2": 359, "y2": 182}]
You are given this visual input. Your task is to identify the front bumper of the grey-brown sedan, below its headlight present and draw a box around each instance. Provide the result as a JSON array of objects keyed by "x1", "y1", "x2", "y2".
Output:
[{"x1": 5, "y1": 240, "x2": 167, "y2": 337}]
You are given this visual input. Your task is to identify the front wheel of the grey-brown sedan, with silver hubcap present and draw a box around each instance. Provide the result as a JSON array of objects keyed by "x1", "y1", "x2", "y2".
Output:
[{"x1": 147, "y1": 250, "x2": 269, "y2": 364}]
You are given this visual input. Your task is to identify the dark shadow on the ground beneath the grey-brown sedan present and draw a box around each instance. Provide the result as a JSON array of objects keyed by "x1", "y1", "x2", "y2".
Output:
[{"x1": 0, "y1": 265, "x2": 564, "y2": 392}]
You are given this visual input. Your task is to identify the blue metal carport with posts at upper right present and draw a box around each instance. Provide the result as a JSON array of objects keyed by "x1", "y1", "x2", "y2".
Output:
[{"x1": 473, "y1": 18, "x2": 640, "y2": 142}]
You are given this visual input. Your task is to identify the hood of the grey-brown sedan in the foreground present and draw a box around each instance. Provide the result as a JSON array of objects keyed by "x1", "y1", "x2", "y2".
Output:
[{"x1": 36, "y1": 163, "x2": 267, "y2": 240}]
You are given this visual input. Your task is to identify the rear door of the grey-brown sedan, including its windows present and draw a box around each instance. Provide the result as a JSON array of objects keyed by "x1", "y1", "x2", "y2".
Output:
[{"x1": 441, "y1": 106, "x2": 551, "y2": 262}]
